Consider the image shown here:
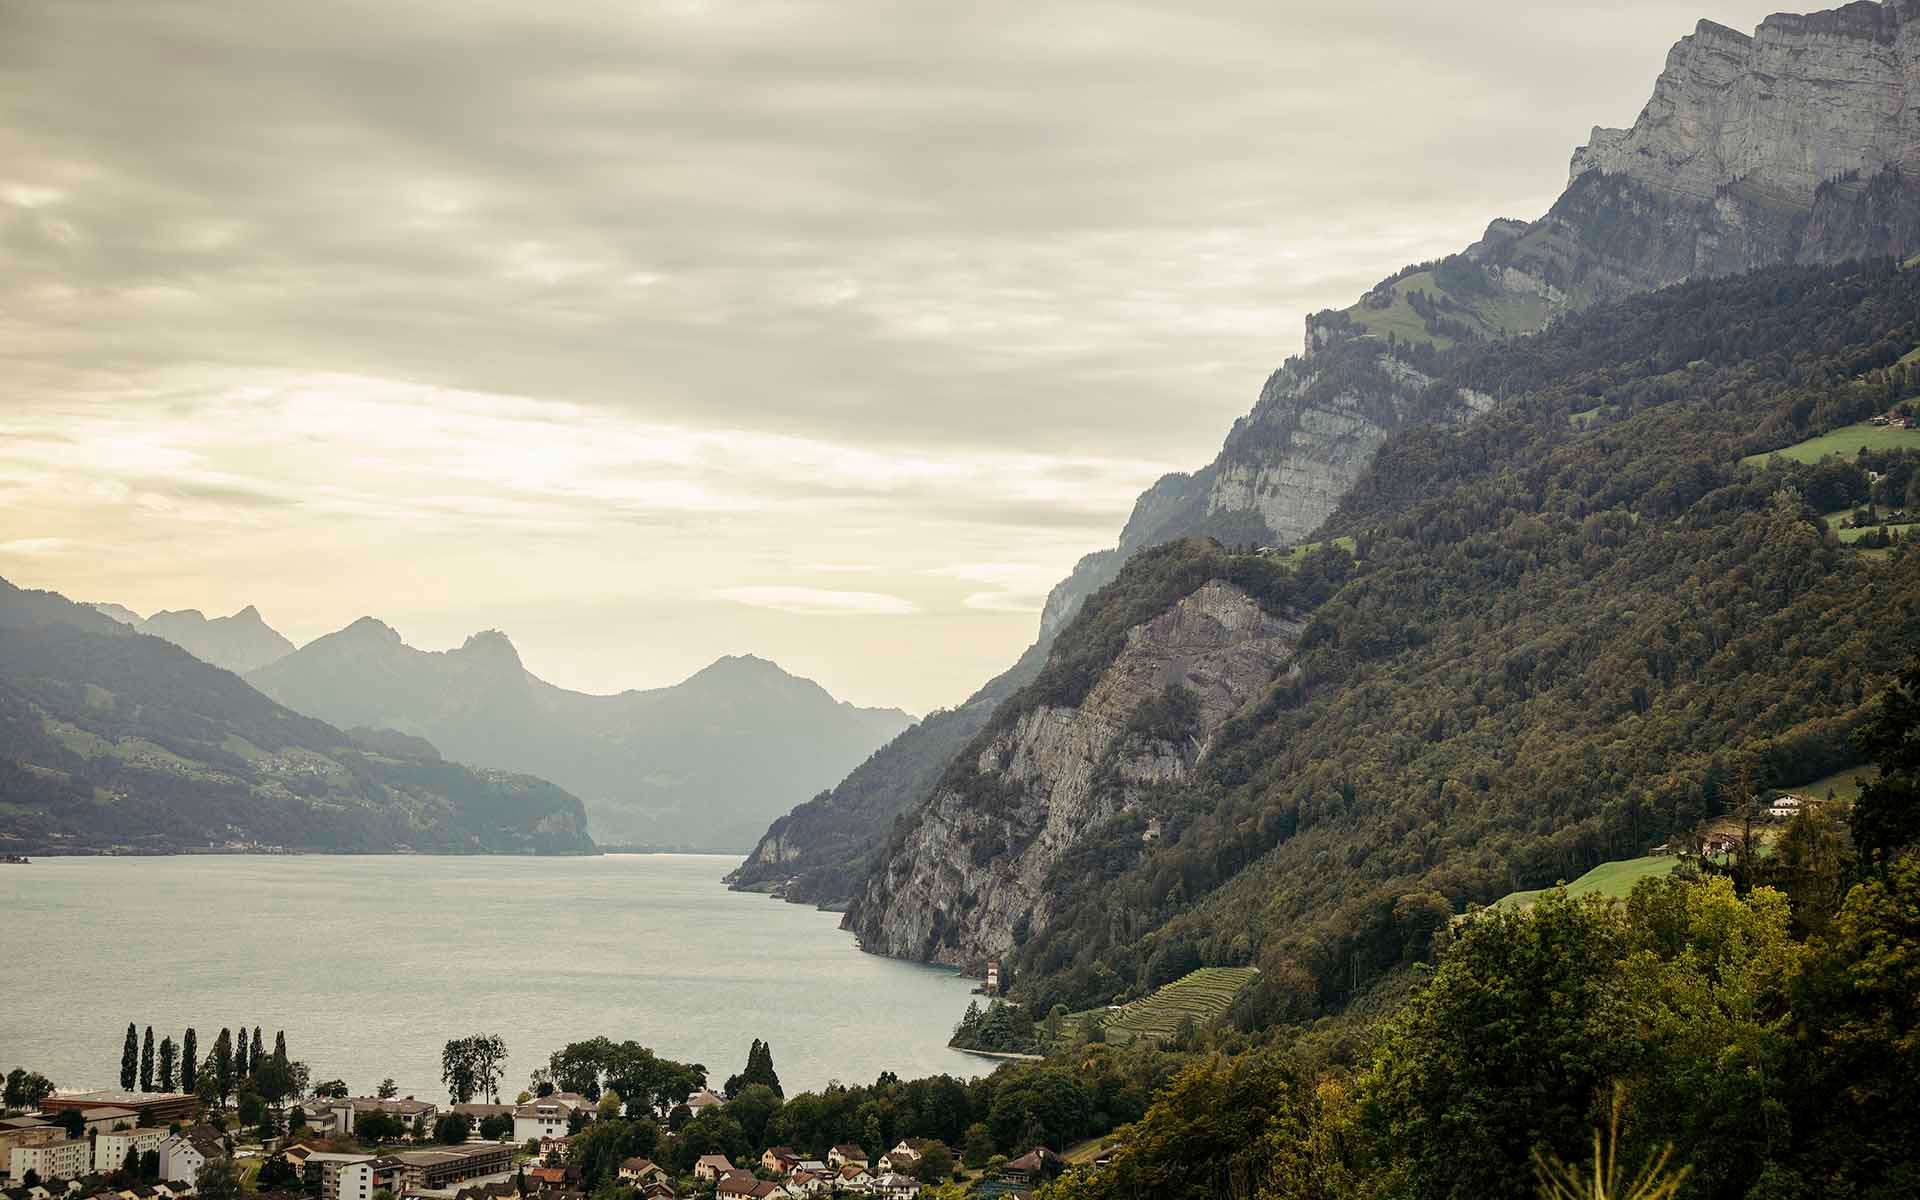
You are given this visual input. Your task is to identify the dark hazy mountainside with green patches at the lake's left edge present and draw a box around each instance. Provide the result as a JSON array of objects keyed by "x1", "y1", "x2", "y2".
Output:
[{"x1": 0, "y1": 580, "x2": 593, "y2": 852}]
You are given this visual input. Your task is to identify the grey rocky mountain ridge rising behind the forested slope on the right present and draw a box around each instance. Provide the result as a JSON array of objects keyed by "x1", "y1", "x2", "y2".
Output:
[{"x1": 739, "y1": 0, "x2": 1920, "y2": 902}]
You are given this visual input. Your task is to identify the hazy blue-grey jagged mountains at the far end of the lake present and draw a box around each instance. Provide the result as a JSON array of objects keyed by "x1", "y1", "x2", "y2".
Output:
[{"x1": 248, "y1": 616, "x2": 912, "y2": 851}]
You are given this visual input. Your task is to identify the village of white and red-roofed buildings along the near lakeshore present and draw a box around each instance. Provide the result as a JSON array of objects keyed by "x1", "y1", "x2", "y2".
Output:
[{"x1": 0, "y1": 1089, "x2": 1066, "y2": 1200}]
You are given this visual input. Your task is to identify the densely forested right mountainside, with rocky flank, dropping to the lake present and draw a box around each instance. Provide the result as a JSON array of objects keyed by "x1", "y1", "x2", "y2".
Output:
[{"x1": 847, "y1": 263, "x2": 1920, "y2": 1020}]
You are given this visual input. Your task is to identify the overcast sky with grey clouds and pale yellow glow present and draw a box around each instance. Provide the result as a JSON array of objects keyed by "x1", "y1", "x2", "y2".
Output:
[{"x1": 0, "y1": 0, "x2": 1772, "y2": 712}]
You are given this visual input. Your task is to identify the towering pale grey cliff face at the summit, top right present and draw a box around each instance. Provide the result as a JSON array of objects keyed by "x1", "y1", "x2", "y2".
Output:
[{"x1": 1308, "y1": 0, "x2": 1920, "y2": 353}]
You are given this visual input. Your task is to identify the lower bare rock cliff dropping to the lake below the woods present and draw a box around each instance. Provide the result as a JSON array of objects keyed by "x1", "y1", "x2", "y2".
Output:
[{"x1": 847, "y1": 580, "x2": 1300, "y2": 966}]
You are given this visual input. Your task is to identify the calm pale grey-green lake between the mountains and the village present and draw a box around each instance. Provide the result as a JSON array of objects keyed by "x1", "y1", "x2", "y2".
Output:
[{"x1": 0, "y1": 854, "x2": 995, "y2": 1098}]
